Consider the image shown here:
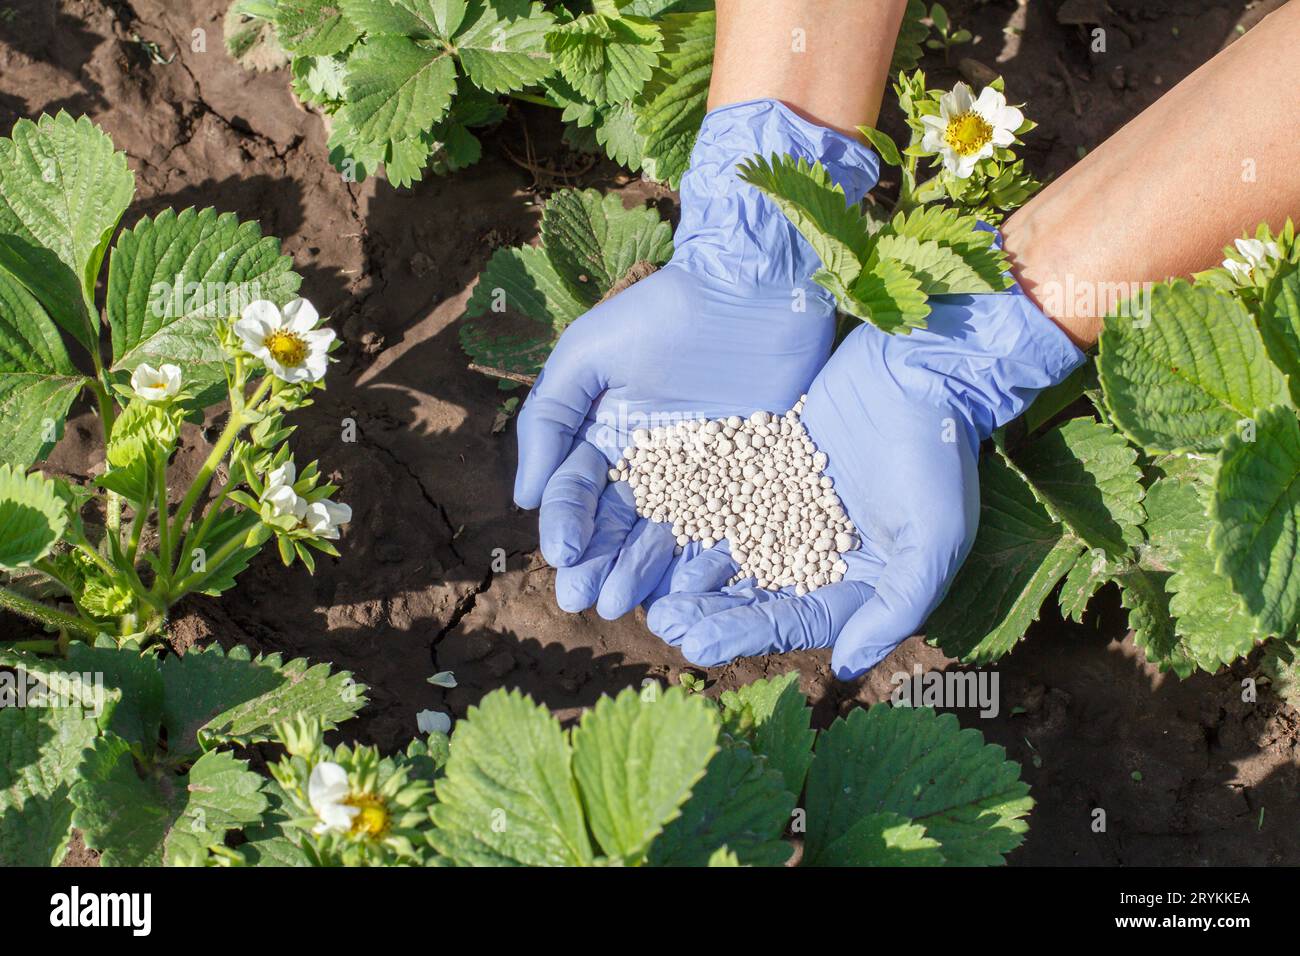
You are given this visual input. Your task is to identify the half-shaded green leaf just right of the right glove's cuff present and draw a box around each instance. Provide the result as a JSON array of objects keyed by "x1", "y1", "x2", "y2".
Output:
[{"x1": 1015, "y1": 418, "x2": 1147, "y2": 558}]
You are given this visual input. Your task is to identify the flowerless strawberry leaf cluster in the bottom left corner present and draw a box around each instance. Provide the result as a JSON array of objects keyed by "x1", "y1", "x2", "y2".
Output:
[{"x1": 0, "y1": 639, "x2": 365, "y2": 866}]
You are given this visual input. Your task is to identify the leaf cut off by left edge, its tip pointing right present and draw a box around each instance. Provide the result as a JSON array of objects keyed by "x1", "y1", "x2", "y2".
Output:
[{"x1": 0, "y1": 265, "x2": 86, "y2": 468}]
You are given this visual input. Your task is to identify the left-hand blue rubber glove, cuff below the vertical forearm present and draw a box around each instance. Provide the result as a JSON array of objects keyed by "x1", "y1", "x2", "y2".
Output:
[{"x1": 515, "y1": 100, "x2": 878, "y2": 619}]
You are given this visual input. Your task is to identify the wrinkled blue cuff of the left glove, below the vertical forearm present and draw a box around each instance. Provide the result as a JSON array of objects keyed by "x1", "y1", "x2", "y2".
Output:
[{"x1": 673, "y1": 99, "x2": 880, "y2": 287}]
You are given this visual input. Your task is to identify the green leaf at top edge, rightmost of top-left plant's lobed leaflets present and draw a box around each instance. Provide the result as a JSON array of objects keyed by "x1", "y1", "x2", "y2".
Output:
[{"x1": 455, "y1": 0, "x2": 555, "y2": 92}]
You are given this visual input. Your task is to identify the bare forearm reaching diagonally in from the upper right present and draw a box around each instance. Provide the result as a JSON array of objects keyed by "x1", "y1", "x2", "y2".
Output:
[{"x1": 1002, "y1": 3, "x2": 1300, "y2": 347}]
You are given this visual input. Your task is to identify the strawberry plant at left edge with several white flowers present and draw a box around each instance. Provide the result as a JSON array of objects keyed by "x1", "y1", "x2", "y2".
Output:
[{"x1": 0, "y1": 113, "x2": 351, "y2": 650}]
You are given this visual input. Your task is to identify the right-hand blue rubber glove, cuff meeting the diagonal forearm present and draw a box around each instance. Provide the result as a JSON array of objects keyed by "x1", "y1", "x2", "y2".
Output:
[{"x1": 647, "y1": 289, "x2": 1084, "y2": 680}]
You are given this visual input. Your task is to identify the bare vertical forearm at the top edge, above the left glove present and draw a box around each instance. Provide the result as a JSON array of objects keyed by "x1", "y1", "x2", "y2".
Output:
[{"x1": 709, "y1": 0, "x2": 906, "y2": 138}]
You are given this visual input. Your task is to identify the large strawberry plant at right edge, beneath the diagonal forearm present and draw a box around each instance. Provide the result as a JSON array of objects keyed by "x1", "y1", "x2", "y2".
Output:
[{"x1": 927, "y1": 222, "x2": 1300, "y2": 676}]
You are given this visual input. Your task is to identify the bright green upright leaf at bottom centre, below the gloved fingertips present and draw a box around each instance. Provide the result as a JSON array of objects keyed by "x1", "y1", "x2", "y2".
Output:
[{"x1": 573, "y1": 687, "x2": 735, "y2": 864}]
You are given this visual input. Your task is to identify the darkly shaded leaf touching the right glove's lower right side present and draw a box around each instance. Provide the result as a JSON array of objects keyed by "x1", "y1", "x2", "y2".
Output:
[{"x1": 926, "y1": 455, "x2": 1084, "y2": 663}]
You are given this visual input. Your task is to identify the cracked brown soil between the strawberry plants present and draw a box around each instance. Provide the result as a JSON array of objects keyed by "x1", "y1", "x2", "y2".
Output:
[{"x1": 0, "y1": 0, "x2": 1300, "y2": 864}]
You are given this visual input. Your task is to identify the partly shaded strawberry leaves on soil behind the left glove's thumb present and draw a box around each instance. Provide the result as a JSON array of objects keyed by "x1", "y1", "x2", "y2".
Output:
[{"x1": 460, "y1": 190, "x2": 672, "y2": 388}]
